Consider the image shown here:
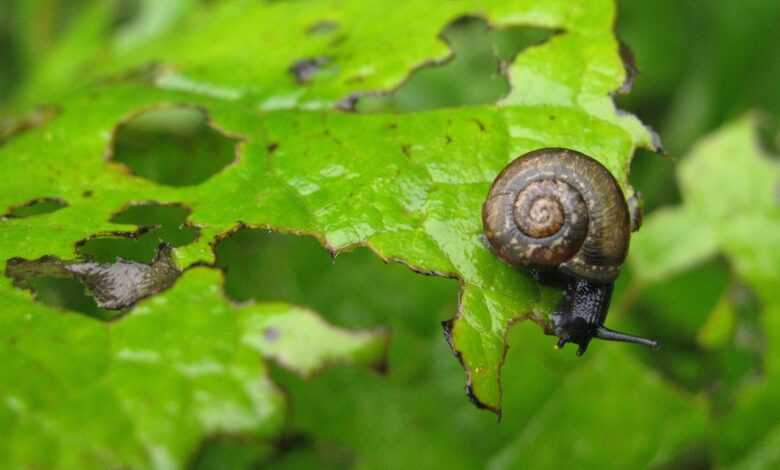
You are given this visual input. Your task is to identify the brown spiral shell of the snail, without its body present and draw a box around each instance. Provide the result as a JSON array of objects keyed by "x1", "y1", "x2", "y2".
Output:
[{"x1": 482, "y1": 148, "x2": 631, "y2": 283}]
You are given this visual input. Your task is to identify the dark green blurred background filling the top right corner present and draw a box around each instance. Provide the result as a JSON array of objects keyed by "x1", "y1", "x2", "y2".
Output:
[{"x1": 616, "y1": 0, "x2": 780, "y2": 209}]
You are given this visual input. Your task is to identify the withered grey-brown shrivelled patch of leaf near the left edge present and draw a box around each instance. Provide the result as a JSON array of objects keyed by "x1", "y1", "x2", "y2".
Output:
[{"x1": 5, "y1": 245, "x2": 180, "y2": 320}]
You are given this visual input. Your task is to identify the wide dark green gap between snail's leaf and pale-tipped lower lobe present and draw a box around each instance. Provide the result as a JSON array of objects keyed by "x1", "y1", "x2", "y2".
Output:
[{"x1": 215, "y1": 228, "x2": 458, "y2": 337}]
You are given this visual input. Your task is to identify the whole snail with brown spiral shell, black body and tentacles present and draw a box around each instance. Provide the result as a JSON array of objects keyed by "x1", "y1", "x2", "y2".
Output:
[{"x1": 482, "y1": 148, "x2": 658, "y2": 356}]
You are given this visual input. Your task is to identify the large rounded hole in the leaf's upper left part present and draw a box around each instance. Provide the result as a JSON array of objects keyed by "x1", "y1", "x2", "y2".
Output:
[{"x1": 113, "y1": 107, "x2": 237, "y2": 186}]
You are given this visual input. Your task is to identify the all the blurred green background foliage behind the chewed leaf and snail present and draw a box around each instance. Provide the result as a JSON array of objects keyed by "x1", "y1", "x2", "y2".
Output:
[{"x1": 0, "y1": 0, "x2": 780, "y2": 469}]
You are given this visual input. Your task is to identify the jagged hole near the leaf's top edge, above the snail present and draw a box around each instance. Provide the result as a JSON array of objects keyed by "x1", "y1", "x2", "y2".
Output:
[{"x1": 348, "y1": 17, "x2": 560, "y2": 112}]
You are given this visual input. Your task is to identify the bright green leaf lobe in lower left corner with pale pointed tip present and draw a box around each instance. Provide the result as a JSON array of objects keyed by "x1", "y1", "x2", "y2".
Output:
[{"x1": 0, "y1": 268, "x2": 387, "y2": 468}]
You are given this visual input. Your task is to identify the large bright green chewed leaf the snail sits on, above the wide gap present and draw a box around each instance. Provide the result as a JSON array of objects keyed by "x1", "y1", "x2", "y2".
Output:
[{"x1": 0, "y1": 1, "x2": 651, "y2": 410}]
